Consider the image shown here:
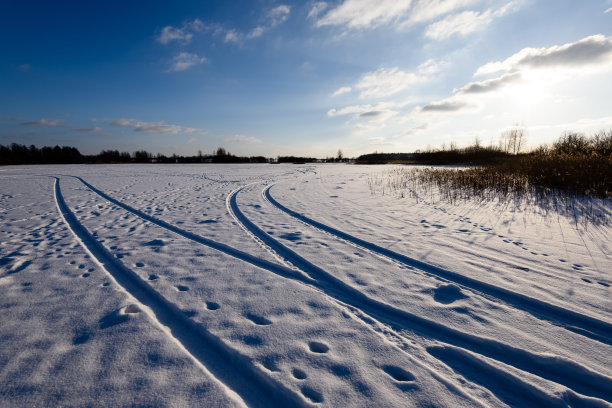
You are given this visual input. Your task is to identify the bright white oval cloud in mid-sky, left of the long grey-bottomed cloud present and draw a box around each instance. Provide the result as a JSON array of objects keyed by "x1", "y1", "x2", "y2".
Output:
[{"x1": 355, "y1": 67, "x2": 423, "y2": 98}]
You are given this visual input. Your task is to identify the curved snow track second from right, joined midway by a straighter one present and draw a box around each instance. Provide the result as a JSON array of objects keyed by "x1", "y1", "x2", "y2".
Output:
[{"x1": 229, "y1": 189, "x2": 612, "y2": 402}]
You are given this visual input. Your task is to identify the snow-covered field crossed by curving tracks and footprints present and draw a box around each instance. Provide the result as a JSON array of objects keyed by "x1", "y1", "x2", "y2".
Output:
[{"x1": 0, "y1": 165, "x2": 612, "y2": 407}]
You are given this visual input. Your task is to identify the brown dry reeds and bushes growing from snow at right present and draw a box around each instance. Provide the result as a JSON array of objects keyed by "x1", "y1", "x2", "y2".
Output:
[{"x1": 368, "y1": 131, "x2": 612, "y2": 227}]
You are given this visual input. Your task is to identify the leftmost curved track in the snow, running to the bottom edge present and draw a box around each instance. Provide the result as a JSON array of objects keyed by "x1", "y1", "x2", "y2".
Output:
[{"x1": 54, "y1": 178, "x2": 306, "y2": 407}]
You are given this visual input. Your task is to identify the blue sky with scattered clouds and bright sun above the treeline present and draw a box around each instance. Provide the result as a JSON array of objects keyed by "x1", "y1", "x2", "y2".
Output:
[{"x1": 0, "y1": 0, "x2": 612, "y2": 157}]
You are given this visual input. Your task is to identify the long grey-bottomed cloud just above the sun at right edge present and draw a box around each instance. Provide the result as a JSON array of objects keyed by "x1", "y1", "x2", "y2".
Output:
[{"x1": 474, "y1": 34, "x2": 612, "y2": 76}]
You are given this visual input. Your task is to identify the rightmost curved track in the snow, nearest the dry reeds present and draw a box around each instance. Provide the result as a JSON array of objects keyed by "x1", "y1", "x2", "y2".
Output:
[{"x1": 263, "y1": 185, "x2": 612, "y2": 345}]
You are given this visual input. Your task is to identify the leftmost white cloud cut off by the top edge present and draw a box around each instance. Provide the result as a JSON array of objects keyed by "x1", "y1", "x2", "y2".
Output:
[{"x1": 316, "y1": 0, "x2": 412, "y2": 29}]
